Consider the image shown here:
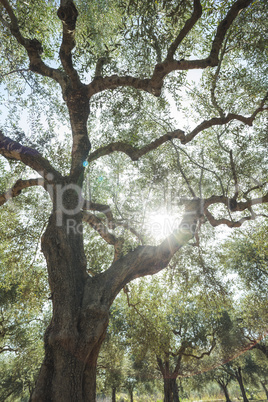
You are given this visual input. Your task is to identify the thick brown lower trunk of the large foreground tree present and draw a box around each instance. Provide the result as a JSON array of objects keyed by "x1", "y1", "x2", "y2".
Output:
[{"x1": 31, "y1": 212, "x2": 109, "y2": 402}]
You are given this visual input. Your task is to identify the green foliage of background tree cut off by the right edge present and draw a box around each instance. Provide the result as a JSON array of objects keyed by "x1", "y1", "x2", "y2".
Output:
[{"x1": 219, "y1": 222, "x2": 268, "y2": 356}]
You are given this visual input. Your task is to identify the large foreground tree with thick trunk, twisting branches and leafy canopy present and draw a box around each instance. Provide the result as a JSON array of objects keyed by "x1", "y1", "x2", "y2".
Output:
[{"x1": 0, "y1": 0, "x2": 268, "y2": 401}]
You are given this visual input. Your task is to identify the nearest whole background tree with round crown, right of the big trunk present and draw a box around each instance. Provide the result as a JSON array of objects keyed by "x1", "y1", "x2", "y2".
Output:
[{"x1": 116, "y1": 264, "x2": 245, "y2": 401}]
